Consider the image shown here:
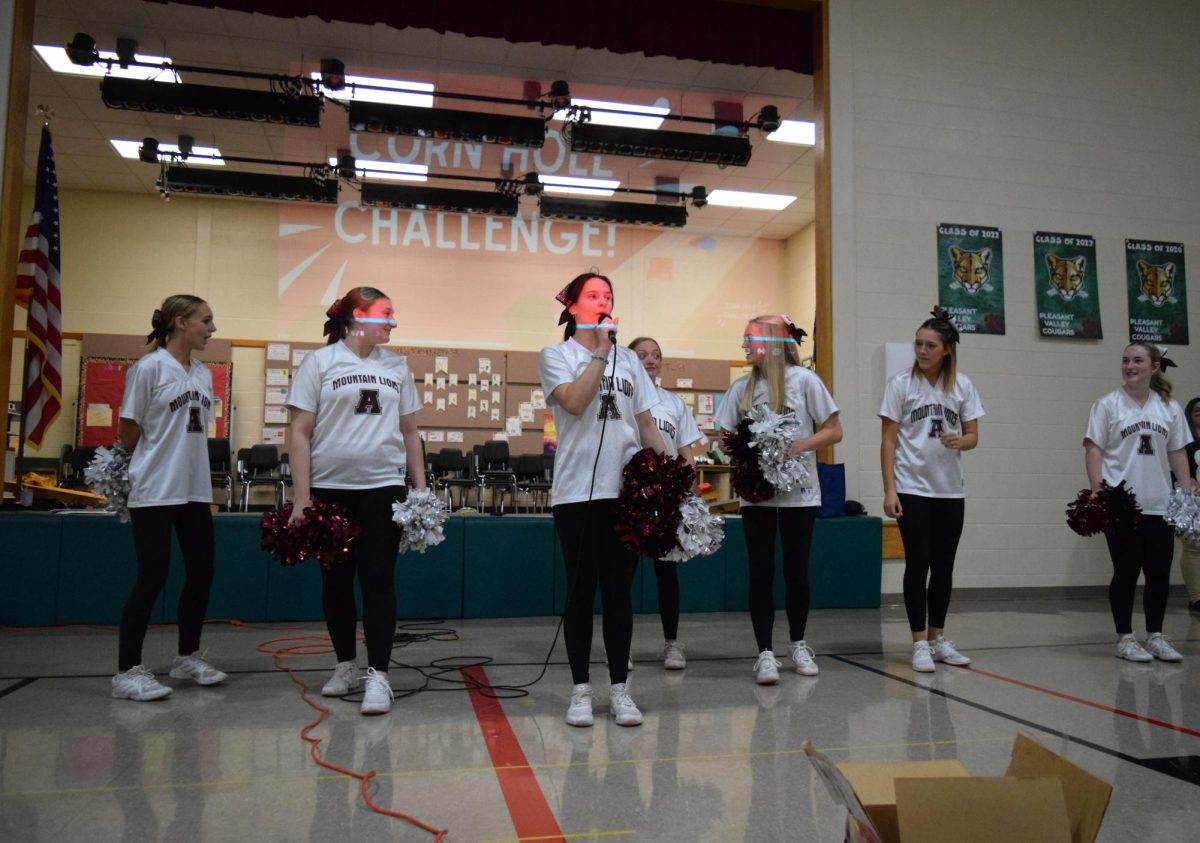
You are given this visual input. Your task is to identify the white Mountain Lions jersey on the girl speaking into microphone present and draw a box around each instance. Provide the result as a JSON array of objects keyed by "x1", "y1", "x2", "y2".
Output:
[{"x1": 538, "y1": 337, "x2": 659, "y2": 507}]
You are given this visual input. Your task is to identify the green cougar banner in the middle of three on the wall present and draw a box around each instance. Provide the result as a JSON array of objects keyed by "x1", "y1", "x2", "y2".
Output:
[{"x1": 1033, "y1": 232, "x2": 1104, "y2": 340}]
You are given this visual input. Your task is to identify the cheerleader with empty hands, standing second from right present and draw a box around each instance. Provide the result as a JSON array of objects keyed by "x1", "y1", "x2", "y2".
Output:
[{"x1": 880, "y1": 307, "x2": 983, "y2": 672}]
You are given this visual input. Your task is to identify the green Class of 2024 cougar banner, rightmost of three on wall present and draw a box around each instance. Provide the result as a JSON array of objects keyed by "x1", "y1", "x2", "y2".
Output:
[{"x1": 1126, "y1": 240, "x2": 1188, "y2": 346}]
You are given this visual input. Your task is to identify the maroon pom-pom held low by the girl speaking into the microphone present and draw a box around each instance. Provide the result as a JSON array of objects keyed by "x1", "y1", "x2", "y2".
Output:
[{"x1": 614, "y1": 448, "x2": 696, "y2": 560}]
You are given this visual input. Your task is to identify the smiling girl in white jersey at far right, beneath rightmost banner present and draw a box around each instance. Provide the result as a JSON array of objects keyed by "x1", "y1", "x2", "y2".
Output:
[{"x1": 1084, "y1": 342, "x2": 1196, "y2": 662}]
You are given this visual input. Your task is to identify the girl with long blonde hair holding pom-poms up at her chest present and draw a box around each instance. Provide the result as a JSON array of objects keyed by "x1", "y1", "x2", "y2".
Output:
[{"x1": 715, "y1": 316, "x2": 841, "y2": 684}]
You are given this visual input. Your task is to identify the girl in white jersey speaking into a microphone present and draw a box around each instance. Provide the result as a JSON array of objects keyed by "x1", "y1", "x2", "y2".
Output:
[{"x1": 538, "y1": 273, "x2": 665, "y2": 727}]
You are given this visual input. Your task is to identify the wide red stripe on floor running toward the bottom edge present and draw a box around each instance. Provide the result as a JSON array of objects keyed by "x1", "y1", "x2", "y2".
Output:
[{"x1": 462, "y1": 666, "x2": 566, "y2": 843}]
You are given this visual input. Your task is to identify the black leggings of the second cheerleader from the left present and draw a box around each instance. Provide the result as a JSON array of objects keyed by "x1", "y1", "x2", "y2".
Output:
[{"x1": 312, "y1": 485, "x2": 407, "y2": 672}]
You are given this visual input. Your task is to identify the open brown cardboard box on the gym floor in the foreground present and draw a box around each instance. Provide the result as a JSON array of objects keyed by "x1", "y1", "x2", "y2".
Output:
[{"x1": 804, "y1": 735, "x2": 1112, "y2": 843}]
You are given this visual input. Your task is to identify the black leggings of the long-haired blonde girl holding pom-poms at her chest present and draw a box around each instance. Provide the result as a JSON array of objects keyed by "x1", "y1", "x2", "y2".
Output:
[{"x1": 742, "y1": 506, "x2": 817, "y2": 651}]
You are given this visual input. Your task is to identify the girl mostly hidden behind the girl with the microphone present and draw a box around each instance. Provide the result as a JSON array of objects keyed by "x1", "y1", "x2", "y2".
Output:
[{"x1": 629, "y1": 336, "x2": 702, "y2": 670}]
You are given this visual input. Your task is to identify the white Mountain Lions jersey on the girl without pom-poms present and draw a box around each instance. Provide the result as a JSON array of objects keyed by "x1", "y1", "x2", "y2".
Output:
[{"x1": 880, "y1": 370, "x2": 984, "y2": 497}]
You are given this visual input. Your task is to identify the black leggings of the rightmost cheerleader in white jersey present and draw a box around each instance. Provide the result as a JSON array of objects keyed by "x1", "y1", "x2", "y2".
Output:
[{"x1": 1104, "y1": 515, "x2": 1175, "y2": 635}]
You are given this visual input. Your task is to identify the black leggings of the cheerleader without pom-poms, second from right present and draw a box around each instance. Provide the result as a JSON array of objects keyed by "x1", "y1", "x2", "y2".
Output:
[{"x1": 896, "y1": 495, "x2": 966, "y2": 632}]
